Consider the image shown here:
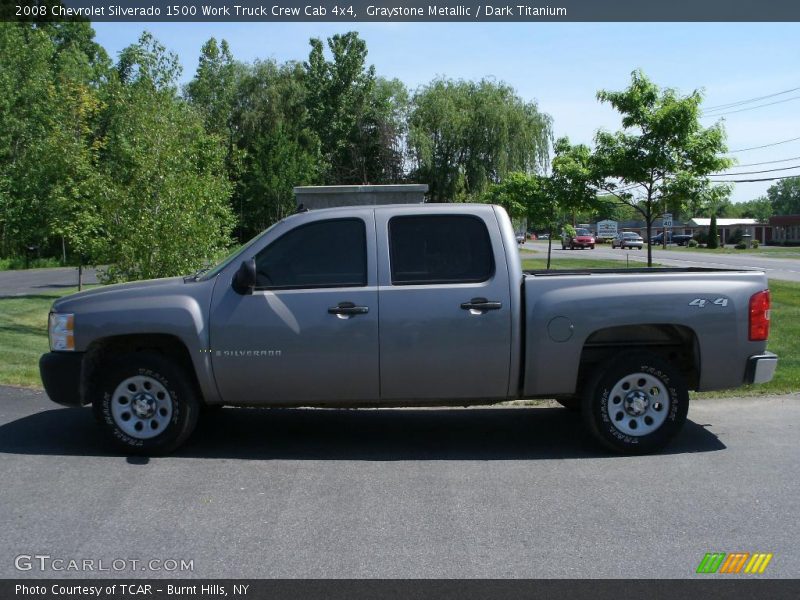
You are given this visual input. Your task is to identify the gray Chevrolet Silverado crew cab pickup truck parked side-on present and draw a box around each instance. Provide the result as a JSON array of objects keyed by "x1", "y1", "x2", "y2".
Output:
[{"x1": 40, "y1": 204, "x2": 777, "y2": 454}]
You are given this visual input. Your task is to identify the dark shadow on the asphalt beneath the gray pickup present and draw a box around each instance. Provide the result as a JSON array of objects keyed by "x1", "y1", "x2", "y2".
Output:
[{"x1": 0, "y1": 408, "x2": 725, "y2": 464}]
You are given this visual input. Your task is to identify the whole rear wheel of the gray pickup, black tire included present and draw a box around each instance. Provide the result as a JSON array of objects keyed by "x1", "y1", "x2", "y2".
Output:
[{"x1": 582, "y1": 352, "x2": 689, "y2": 454}]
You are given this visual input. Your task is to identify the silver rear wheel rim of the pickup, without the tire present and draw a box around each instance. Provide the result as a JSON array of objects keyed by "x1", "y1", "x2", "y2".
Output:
[{"x1": 608, "y1": 373, "x2": 669, "y2": 437}]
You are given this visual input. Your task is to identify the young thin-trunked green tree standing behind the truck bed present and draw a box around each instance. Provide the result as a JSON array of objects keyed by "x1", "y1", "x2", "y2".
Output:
[{"x1": 594, "y1": 71, "x2": 732, "y2": 266}]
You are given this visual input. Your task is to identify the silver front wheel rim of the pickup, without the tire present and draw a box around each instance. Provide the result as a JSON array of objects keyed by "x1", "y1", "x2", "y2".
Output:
[{"x1": 111, "y1": 375, "x2": 173, "y2": 440}]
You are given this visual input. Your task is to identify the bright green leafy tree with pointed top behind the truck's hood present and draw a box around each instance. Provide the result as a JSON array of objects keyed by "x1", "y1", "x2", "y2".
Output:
[{"x1": 100, "y1": 33, "x2": 233, "y2": 281}]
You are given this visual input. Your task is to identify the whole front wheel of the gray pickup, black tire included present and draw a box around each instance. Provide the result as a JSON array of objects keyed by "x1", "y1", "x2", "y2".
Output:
[{"x1": 89, "y1": 352, "x2": 200, "y2": 456}]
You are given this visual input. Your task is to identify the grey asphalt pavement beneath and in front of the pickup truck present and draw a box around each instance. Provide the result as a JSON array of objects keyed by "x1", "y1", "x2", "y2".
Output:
[{"x1": 0, "y1": 387, "x2": 800, "y2": 578}]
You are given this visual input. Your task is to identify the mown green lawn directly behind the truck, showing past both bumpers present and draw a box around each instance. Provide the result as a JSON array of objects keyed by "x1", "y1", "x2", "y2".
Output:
[{"x1": 0, "y1": 282, "x2": 800, "y2": 397}]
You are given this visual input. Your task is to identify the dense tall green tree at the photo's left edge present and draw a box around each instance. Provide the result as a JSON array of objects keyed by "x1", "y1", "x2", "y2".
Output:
[{"x1": 0, "y1": 22, "x2": 109, "y2": 255}]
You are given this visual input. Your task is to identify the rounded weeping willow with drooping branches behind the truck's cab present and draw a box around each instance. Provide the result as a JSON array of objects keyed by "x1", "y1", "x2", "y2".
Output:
[{"x1": 409, "y1": 79, "x2": 551, "y2": 202}]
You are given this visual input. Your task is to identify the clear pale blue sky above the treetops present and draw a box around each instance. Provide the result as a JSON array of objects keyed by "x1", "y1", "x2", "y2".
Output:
[{"x1": 94, "y1": 23, "x2": 800, "y2": 201}]
